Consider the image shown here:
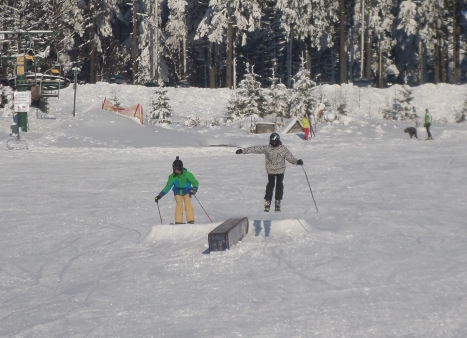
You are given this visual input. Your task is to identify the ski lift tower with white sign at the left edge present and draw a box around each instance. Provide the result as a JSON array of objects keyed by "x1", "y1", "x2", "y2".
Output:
[{"x1": 0, "y1": 30, "x2": 55, "y2": 132}]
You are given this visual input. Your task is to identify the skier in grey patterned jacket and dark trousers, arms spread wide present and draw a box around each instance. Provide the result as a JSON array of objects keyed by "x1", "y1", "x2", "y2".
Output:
[{"x1": 236, "y1": 133, "x2": 303, "y2": 211}]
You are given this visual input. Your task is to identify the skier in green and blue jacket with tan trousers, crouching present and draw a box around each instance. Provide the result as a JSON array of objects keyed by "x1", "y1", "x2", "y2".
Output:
[{"x1": 154, "y1": 156, "x2": 199, "y2": 224}]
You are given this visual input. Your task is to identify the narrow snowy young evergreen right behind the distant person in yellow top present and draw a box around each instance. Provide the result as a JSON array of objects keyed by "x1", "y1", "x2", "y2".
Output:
[{"x1": 290, "y1": 66, "x2": 316, "y2": 117}]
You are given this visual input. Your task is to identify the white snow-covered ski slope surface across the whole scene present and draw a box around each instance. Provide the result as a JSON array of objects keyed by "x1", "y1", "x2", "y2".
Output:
[{"x1": 0, "y1": 83, "x2": 467, "y2": 338}]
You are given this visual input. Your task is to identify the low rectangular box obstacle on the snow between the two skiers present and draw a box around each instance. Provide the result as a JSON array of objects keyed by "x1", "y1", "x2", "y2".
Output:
[{"x1": 208, "y1": 217, "x2": 248, "y2": 252}]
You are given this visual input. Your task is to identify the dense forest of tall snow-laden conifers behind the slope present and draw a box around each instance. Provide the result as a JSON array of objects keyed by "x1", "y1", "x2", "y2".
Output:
[{"x1": 0, "y1": 0, "x2": 467, "y2": 88}]
